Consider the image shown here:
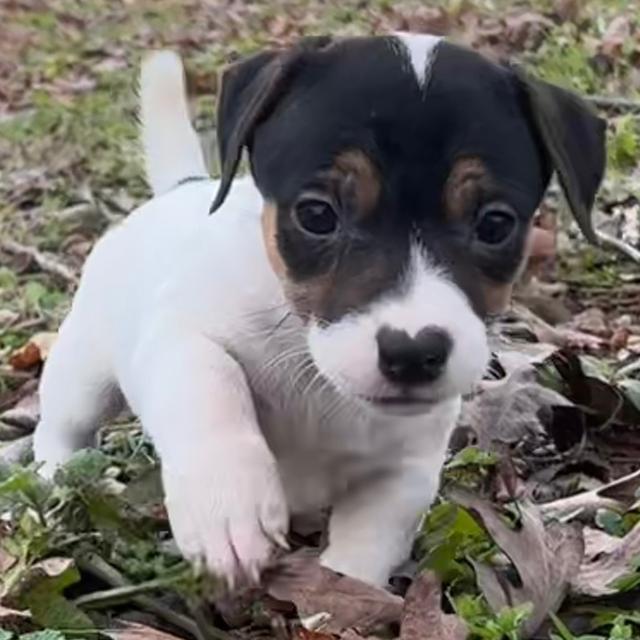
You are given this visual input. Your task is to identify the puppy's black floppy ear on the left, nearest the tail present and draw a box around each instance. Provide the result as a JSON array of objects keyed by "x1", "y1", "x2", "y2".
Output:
[{"x1": 211, "y1": 36, "x2": 331, "y2": 212}]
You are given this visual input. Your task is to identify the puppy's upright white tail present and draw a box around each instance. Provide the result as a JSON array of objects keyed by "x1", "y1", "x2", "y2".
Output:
[{"x1": 140, "y1": 51, "x2": 208, "y2": 195}]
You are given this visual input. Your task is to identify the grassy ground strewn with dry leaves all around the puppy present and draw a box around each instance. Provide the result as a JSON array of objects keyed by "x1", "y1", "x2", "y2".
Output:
[{"x1": 0, "y1": 0, "x2": 640, "y2": 640}]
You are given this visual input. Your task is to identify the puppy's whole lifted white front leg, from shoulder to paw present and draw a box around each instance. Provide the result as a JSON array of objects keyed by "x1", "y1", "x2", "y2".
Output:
[{"x1": 135, "y1": 332, "x2": 288, "y2": 584}]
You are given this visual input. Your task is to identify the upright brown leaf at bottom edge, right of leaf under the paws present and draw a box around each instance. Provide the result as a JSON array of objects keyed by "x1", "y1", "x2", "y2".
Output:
[{"x1": 400, "y1": 572, "x2": 468, "y2": 640}]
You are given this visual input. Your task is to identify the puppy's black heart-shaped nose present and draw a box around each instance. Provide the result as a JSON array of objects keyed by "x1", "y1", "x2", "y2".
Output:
[{"x1": 376, "y1": 327, "x2": 453, "y2": 385}]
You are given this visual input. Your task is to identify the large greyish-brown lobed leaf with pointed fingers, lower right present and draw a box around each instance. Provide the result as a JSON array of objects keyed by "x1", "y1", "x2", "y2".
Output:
[{"x1": 451, "y1": 491, "x2": 584, "y2": 638}]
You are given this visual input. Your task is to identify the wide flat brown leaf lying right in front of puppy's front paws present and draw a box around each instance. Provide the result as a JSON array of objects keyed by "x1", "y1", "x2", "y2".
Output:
[{"x1": 264, "y1": 552, "x2": 402, "y2": 635}]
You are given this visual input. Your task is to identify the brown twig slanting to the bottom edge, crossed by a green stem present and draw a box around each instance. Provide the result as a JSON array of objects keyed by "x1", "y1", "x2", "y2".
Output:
[{"x1": 76, "y1": 553, "x2": 230, "y2": 640}]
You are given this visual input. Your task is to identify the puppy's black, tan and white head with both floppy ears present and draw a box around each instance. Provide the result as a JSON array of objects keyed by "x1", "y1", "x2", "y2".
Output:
[{"x1": 212, "y1": 35, "x2": 604, "y2": 413}]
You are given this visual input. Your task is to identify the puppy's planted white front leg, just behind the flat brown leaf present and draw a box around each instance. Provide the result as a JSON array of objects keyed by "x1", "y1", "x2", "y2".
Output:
[{"x1": 321, "y1": 466, "x2": 440, "y2": 586}]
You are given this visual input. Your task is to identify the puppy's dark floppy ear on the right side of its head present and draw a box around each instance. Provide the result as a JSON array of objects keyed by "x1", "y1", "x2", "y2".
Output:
[{"x1": 513, "y1": 68, "x2": 606, "y2": 243}]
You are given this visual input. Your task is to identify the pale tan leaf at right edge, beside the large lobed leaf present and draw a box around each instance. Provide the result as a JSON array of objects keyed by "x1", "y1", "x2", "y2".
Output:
[{"x1": 571, "y1": 524, "x2": 640, "y2": 598}]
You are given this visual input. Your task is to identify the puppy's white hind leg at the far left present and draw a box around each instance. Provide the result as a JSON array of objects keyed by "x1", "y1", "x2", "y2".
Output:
[{"x1": 34, "y1": 317, "x2": 122, "y2": 477}]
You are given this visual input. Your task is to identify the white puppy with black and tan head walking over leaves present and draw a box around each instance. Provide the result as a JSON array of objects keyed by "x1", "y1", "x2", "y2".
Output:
[{"x1": 35, "y1": 34, "x2": 605, "y2": 584}]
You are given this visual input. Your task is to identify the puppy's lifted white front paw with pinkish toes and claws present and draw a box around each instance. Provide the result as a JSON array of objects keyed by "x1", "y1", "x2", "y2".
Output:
[{"x1": 163, "y1": 452, "x2": 288, "y2": 588}]
